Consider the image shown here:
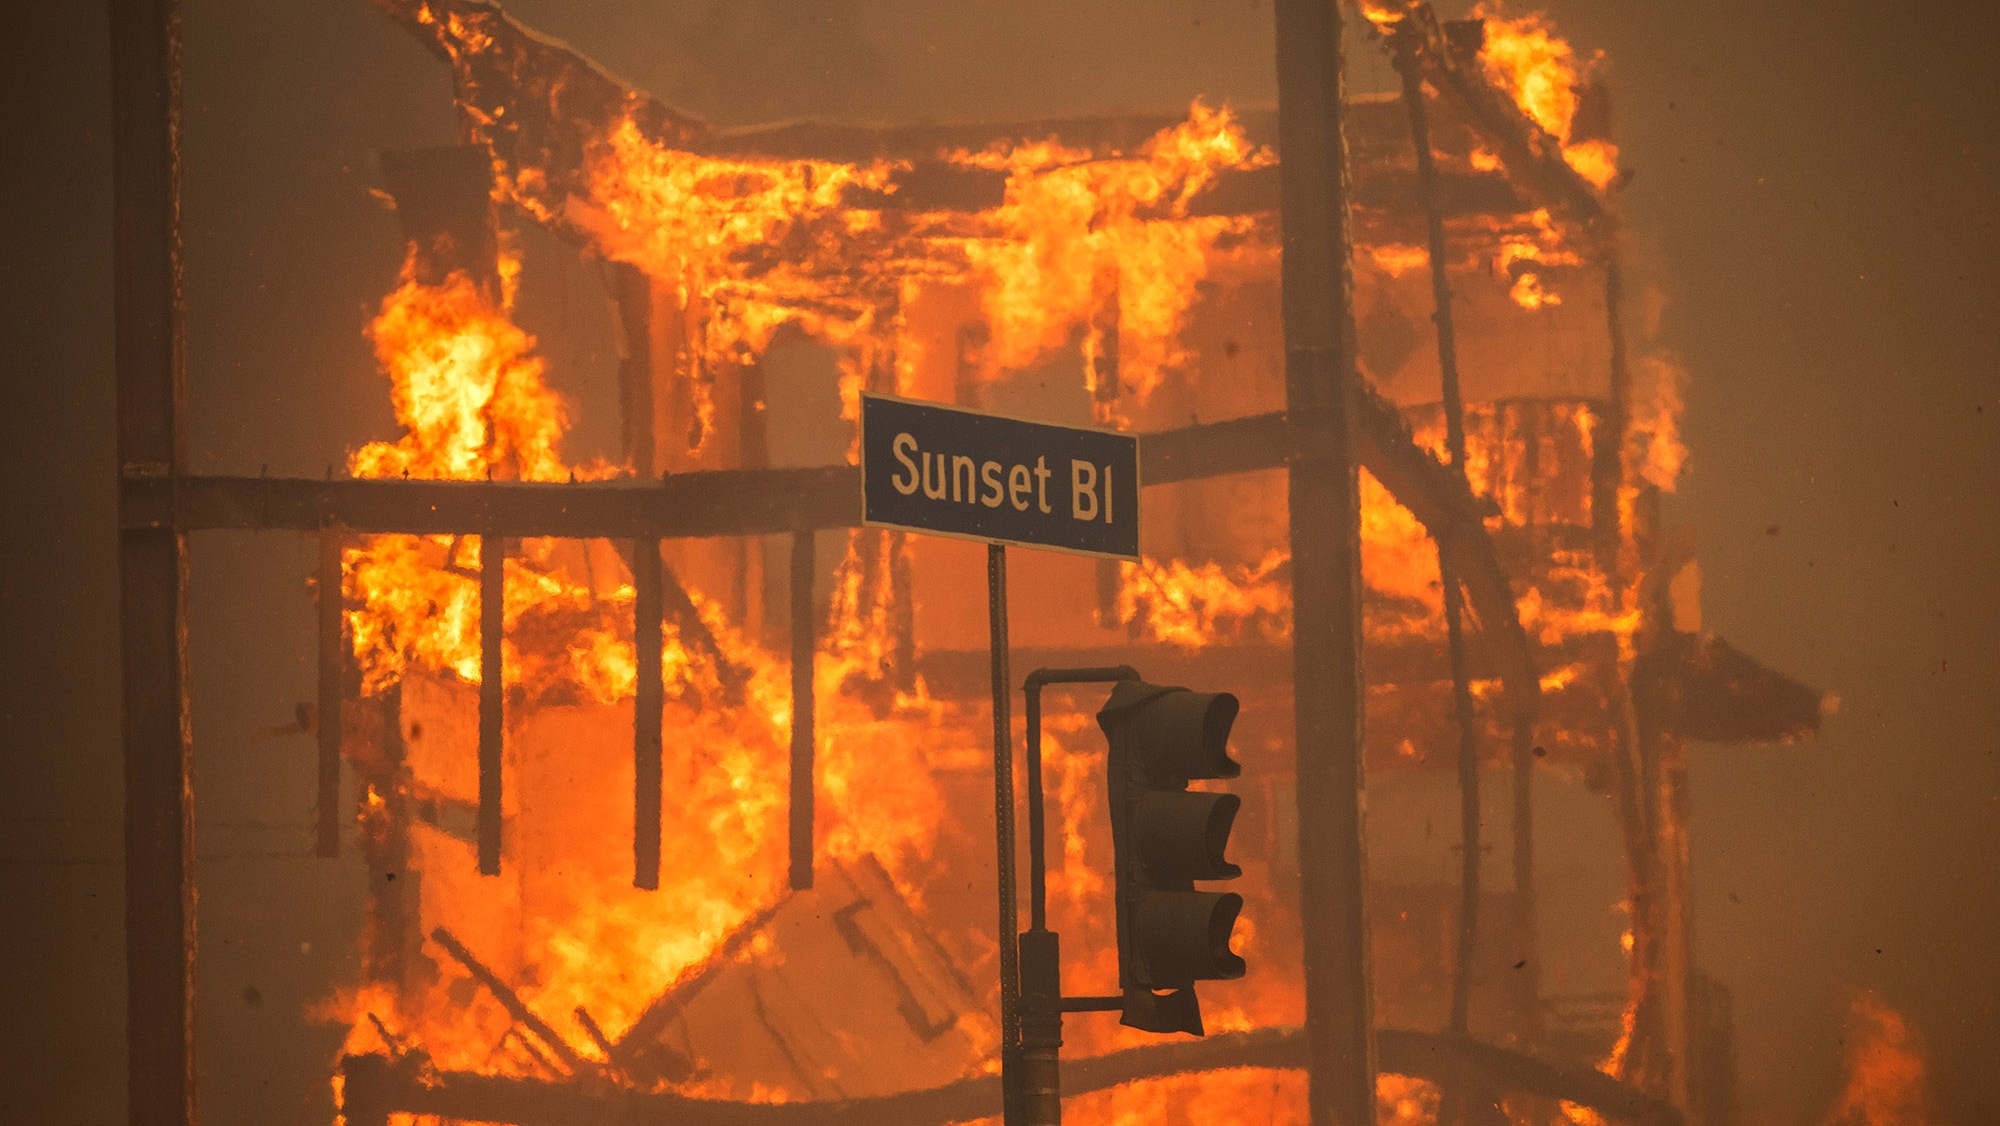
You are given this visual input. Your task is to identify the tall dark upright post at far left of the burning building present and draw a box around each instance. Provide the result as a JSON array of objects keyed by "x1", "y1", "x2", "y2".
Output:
[{"x1": 110, "y1": 0, "x2": 194, "y2": 1126}]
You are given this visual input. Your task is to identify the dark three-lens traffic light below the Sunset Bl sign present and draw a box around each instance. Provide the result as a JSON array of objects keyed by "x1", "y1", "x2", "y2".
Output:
[{"x1": 1098, "y1": 680, "x2": 1244, "y2": 1036}]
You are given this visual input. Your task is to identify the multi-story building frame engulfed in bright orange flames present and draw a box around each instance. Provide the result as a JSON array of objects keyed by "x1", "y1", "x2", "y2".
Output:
[{"x1": 113, "y1": 0, "x2": 1822, "y2": 1126}]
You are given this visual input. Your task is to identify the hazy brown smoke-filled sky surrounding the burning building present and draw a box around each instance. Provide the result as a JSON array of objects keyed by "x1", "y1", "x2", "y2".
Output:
[{"x1": 0, "y1": 0, "x2": 2000, "y2": 1122}]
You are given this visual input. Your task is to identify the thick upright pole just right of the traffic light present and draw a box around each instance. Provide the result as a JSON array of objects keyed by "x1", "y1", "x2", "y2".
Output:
[{"x1": 1276, "y1": 0, "x2": 1376, "y2": 1126}]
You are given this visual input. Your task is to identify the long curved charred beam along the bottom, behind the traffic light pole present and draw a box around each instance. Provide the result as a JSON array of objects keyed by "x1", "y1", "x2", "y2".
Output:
[{"x1": 340, "y1": 1028, "x2": 1684, "y2": 1126}]
